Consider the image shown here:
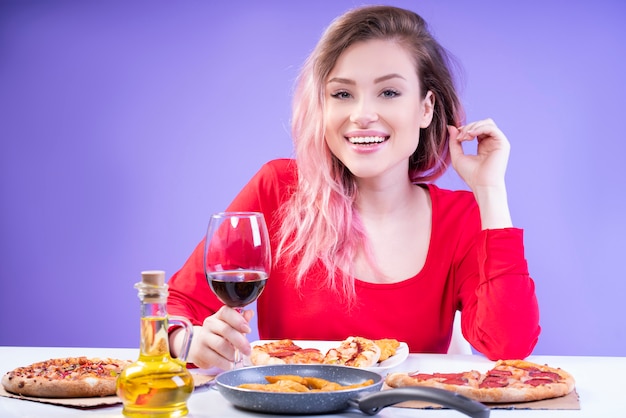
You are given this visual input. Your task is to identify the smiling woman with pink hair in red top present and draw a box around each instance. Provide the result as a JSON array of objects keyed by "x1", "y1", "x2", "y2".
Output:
[{"x1": 168, "y1": 6, "x2": 540, "y2": 369}]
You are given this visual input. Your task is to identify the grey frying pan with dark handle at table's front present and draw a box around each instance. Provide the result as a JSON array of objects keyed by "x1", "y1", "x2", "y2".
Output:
[{"x1": 215, "y1": 364, "x2": 490, "y2": 418}]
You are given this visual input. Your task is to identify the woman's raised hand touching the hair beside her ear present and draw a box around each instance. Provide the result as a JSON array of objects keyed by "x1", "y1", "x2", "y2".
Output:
[{"x1": 448, "y1": 119, "x2": 511, "y2": 193}]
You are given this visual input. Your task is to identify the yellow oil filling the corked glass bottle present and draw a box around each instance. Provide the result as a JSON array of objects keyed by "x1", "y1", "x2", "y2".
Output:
[{"x1": 117, "y1": 317, "x2": 193, "y2": 418}]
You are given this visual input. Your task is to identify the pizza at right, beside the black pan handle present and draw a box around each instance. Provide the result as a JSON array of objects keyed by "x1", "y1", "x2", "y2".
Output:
[{"x1": 385, "y1": 360, "x2": 575, "y2": 403}]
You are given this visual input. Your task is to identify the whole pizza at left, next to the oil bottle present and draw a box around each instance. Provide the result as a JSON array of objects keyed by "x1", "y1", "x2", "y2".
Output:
[{"x1": 2, "y1": 357, "x2": 131, "y2": 398}]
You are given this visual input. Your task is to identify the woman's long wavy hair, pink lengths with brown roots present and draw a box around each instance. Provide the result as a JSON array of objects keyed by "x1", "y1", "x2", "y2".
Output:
[{"x1": 277, "y1": 6, "x2": 463, "y2": 301}]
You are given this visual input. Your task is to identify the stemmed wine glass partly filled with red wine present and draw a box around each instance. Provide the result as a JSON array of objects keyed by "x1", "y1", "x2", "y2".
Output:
[{"x1": 204, "y1": 212, "x2": 271, "y2": 369}]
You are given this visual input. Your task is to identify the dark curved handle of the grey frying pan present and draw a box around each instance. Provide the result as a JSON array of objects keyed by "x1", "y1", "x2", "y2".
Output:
[{"x1": 349, "y1": 387, "x2": 491, "y2": 418}]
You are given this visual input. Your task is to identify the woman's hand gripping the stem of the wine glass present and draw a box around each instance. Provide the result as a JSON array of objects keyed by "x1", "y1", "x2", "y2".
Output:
[{"x1": 169, "y1": 306, "x2": 254, "y2": 370}]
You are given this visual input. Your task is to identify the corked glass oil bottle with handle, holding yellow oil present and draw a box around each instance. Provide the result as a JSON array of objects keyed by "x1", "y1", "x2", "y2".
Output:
[{"x1": 117, "y1": 270, "x2": 194, "y2": 418}]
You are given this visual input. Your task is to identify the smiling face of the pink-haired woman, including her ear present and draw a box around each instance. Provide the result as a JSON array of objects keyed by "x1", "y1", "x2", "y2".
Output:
[{"x1": 324, "y1": 40, "x2": 434, "y2": 179}]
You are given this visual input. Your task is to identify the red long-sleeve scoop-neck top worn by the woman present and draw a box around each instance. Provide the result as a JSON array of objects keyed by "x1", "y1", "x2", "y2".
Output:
[{"x1": 168, "y1": 159, "x2": 540, "y2": 360}]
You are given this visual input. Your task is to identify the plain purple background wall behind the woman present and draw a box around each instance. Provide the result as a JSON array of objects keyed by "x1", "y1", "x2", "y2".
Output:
[{"x1": 0, "y1": 0, "x2": 626, "y2": 356}]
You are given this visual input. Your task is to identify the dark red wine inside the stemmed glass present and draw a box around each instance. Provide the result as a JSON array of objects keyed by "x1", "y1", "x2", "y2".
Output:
[{"x1": 207, "y1": 270, "x2": 267, "y2": 308}]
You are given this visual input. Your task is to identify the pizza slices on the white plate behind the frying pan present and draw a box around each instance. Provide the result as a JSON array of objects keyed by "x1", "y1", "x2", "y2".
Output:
[{"x1": 250, "y1": 337, "x2": 390, "y2": 367}]
